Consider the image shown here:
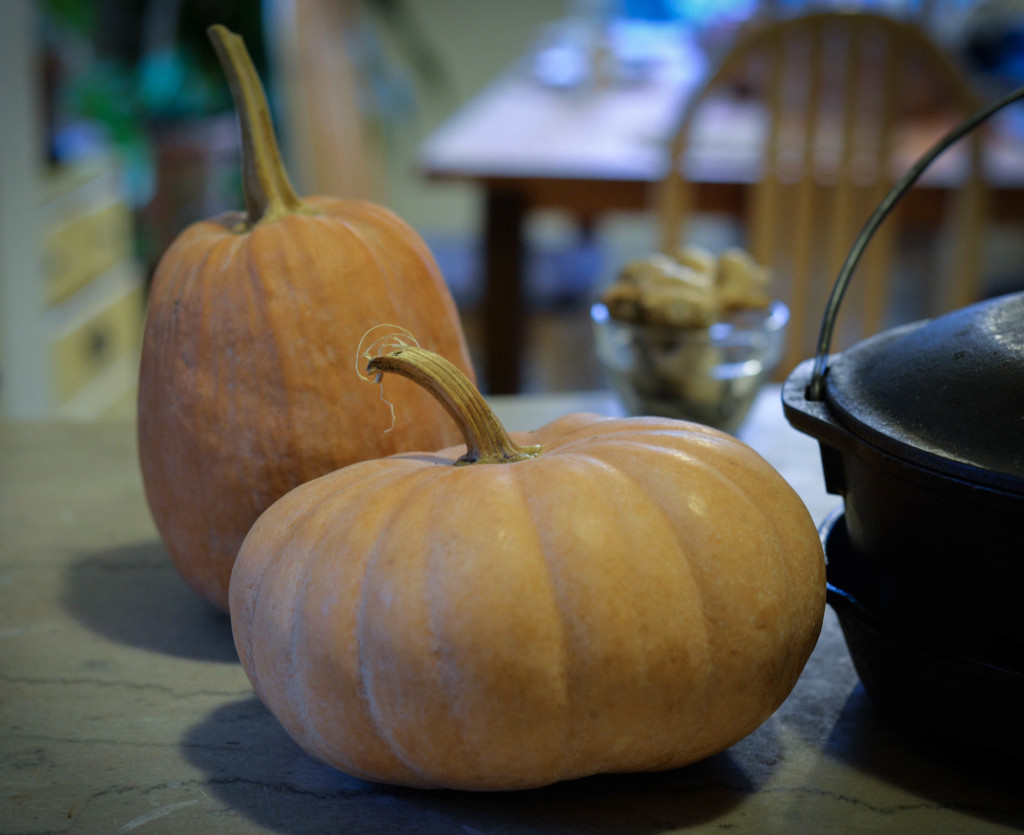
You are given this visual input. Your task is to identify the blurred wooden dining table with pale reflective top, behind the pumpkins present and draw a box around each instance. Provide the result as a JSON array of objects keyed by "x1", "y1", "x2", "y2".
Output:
[{"x1": 418, "y1": 37, "x2": 1024, "y2": 393}]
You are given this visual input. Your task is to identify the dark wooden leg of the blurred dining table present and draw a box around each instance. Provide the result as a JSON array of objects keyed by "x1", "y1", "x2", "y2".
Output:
[{"x1": 483, "y1": 189, "x2": 526, "y2": 394}]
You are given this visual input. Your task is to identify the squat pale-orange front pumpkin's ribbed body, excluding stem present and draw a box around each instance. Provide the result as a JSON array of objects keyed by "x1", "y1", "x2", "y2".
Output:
[{"x1": 230, "y1": 415, "x2": 825, "y2": 790}]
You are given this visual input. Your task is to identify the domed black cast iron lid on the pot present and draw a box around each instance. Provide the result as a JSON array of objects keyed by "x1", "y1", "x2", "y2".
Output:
[{"x1": 824, "y1": 292, "x2": 1024, "y2": 494}]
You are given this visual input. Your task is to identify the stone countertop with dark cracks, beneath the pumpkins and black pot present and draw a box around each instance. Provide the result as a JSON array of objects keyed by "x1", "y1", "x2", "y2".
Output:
[{"x1": 0, "y1": 387, "x2": 1024, "y2": 835}]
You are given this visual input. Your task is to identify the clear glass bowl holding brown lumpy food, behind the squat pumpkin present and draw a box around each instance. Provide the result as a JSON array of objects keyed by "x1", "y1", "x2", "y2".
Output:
[{"x1": 591, "y1": 301, "x2": 790, "y2": 432}]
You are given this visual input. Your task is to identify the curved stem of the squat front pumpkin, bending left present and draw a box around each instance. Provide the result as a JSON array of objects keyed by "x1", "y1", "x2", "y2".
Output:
[{"x1": 367, "y1": 346, "x2": 541, "y2": 464}]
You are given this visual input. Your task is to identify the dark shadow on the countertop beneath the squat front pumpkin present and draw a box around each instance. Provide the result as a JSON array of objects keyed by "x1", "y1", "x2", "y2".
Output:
[{"x1": 181, "y1": 697, "x2": 767, "y2": 835}]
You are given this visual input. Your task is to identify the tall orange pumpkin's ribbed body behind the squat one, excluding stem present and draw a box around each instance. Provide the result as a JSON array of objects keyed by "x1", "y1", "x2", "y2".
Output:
[{"x1": 138, "y1": 198, "x2": 472, "y2": 610}]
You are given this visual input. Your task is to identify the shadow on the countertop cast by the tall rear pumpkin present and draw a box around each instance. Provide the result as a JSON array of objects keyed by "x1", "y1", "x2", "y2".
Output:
[{"x1": 60, "y1": 540, "x2": 238, "y2": 663}]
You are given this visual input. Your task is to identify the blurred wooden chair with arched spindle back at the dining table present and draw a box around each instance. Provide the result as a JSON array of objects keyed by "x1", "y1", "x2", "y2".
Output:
[{"x1": 659, "y1": 12, "x2": 987, "y2": 379}]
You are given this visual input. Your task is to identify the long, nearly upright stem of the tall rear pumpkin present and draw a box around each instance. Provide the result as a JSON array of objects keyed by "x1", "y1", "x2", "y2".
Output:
[{"x1": 206, "y1": 24, "x2": 305, "y2": 226}]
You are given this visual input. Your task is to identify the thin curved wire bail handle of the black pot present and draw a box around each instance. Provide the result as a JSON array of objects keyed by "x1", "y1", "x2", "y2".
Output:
[{"x1": 806, "y1": 87, "x2": 1024, "y2": 401}]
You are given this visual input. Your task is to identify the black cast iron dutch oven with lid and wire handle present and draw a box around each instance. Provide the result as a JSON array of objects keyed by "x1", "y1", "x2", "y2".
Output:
[{"x1": 782, "y1": 90, "x2": 1024, "y2": 754}]
